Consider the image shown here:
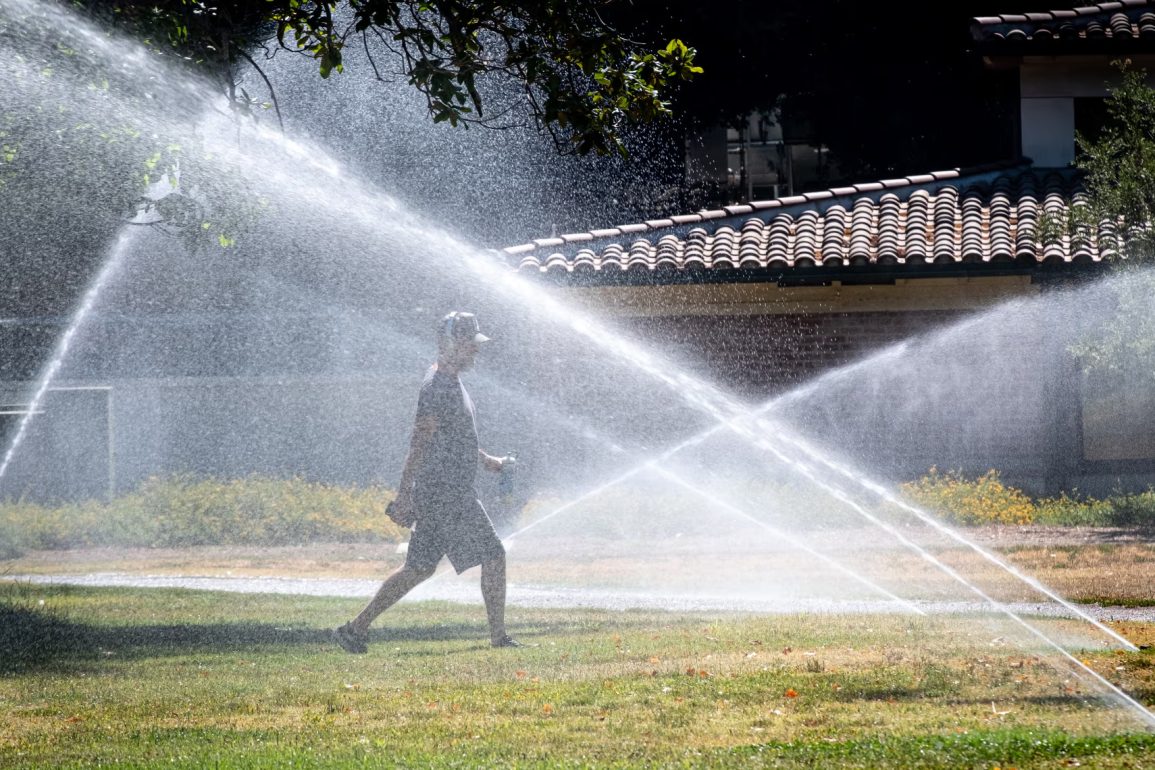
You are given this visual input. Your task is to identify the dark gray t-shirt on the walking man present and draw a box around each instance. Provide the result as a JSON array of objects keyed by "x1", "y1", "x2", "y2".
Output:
[{"x1": 413, "y1": 366, "x2": 478, "y2": 499}]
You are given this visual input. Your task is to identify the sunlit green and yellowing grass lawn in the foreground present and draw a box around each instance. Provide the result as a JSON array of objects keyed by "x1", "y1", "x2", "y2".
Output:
[{"x1": 0, "y1": 584, "x2": 1155, "y2": 769}]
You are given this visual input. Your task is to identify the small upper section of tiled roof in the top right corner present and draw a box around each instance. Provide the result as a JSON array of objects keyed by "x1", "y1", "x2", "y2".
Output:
[{"x1": 971, "y1": 0, "x2": 1155, "y2": 50}]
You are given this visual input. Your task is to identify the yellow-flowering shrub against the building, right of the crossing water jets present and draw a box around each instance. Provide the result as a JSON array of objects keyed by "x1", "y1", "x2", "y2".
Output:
[{"x1": 902, "y1": 468, "x2": 1036, "y2": 525}]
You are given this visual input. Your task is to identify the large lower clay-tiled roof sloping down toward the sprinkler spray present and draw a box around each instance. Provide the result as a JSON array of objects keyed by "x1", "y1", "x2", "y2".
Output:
[{"x1": 505, "y1": 164, "x2": 1106, "y2": 278}]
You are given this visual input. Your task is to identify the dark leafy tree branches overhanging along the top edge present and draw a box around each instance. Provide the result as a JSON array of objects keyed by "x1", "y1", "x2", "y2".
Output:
[{"x1": 79, "y1": 0, "x2": 701, "y2": 154}]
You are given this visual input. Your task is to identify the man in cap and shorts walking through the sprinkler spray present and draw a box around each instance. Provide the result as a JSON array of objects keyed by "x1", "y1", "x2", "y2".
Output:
[{"x1": 333, "y1": 312, "x2": 521, "y2": 652}]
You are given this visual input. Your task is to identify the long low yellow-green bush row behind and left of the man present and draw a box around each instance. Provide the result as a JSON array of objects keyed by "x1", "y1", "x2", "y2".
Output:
[{"x1": 0, "y1": 476, "x2": 405, "y2": 550}]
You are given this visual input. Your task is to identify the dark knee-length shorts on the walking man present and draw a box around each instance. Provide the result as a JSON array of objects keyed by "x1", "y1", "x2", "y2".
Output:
[{"x1": 405, "y1": 495, "x2": 505, "y2": 575}]
